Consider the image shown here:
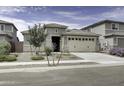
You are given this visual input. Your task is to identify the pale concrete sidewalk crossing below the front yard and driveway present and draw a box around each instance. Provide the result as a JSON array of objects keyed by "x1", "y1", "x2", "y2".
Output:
[{"x1": 0, "y1": 60, "x2": 124, "y2": 67}]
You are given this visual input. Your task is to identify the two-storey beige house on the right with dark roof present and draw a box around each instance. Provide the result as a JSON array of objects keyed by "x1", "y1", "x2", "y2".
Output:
[{"x1": 81, "y1": 20, "x2": 124, "y2": 50}]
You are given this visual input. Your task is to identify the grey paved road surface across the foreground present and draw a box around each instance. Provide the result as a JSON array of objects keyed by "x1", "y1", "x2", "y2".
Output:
[{"x1": 0, "y1": 66, "x2": 124, "y2": 86}]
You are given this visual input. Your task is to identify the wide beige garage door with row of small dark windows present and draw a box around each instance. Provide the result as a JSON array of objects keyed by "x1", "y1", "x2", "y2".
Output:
[{"x1": 67, "y1": 38, "x2": 96, "y2": 52}]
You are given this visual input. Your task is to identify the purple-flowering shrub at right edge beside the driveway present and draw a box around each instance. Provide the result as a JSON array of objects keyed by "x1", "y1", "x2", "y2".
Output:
[{"x1": 109, "y1": 48, "x2": 124, "y2": 57}]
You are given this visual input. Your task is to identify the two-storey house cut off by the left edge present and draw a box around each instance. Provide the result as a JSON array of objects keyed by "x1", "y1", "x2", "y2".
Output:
[{"x1": 0, "y1": 20, "x2": 22, "y2": 52}]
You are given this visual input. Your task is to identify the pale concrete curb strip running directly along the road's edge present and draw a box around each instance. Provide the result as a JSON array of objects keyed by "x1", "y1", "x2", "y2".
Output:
[{"x1": 0, "y1": 63, "x2": 124, "y2": 74}]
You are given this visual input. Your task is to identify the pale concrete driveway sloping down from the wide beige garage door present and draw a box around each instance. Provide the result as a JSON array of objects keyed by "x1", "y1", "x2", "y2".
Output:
[{"x1": 72, "y1": 53, "x2": 124, "y2": 64}]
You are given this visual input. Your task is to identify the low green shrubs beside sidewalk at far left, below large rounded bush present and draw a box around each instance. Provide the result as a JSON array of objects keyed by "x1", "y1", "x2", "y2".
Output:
[{"x1": 0, "y1": 55, "x2": 17, "y2": 62}]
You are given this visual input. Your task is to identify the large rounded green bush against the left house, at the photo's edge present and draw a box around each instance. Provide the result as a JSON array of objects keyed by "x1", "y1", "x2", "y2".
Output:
[{"x1": 0, "y1": 41, "x2": 11, "y2": 55}]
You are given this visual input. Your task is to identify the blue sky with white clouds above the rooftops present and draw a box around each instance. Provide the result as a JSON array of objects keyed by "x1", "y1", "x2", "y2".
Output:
[{"x1": 0, "y1": 6, "x2": 124, "y2": 41}]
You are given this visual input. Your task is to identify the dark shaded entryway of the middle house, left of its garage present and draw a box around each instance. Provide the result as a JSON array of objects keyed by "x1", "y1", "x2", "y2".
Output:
[{"x1": 52, "y1": 36, "x2": 60, "y2": 52}]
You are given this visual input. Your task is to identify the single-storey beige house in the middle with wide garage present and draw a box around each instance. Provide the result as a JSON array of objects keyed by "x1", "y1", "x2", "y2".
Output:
[{"x1": 22, "y1": 23, "x2": 99, "y2": 52}]
